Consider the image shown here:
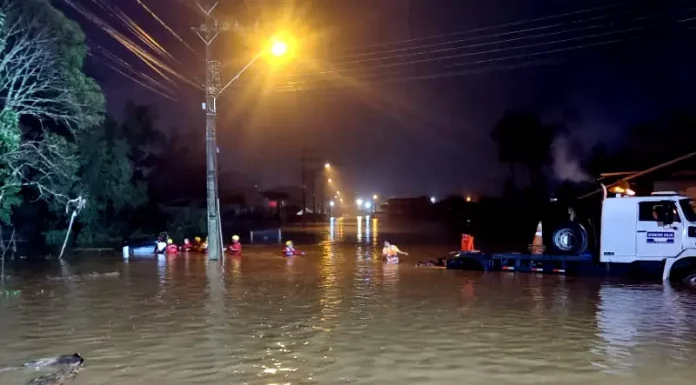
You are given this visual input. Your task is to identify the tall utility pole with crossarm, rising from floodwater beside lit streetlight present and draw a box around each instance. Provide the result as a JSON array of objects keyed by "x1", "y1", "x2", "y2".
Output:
[{"x1": 193, "y1": 0, "x2": 228, "y2": 260}]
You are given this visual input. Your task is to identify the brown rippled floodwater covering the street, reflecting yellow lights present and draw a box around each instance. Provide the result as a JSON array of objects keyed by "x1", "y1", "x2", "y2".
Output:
[{"x1": 0, "y1": 218, "x2": 696, "y2": 385}]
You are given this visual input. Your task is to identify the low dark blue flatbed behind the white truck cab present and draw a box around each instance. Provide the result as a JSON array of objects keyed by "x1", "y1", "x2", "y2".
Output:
[{"x1": 447, "y1": 252, "x2": 664, "y2": 278}]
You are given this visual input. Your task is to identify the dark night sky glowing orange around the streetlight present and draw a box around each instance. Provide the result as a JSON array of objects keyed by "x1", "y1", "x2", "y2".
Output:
[{"x1": 58, "y1": 0, "x2": 696, "y2": 196}]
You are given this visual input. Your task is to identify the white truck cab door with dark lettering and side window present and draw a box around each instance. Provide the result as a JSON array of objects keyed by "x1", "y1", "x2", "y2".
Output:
[{"x1": 636, "y1": 201, "x2": 684, "y2": 260}]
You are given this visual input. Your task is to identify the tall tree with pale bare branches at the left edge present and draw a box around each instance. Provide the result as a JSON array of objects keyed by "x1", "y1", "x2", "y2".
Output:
[{"x1": 0, "y1": 0, "x2": 103, "y2": 255}]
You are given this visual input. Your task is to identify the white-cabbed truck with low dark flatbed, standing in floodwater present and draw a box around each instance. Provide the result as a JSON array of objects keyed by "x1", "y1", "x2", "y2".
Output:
[{"x1": 447, "y1": 190, "x2": 696, "y2": 285}]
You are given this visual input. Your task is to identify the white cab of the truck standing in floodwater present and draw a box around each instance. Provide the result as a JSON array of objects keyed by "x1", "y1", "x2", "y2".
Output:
[{"x1": 599, "y1": 192, "x2": 696, "y2": 283}]
